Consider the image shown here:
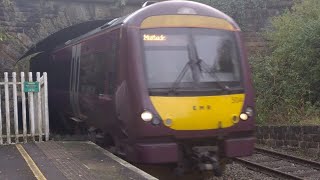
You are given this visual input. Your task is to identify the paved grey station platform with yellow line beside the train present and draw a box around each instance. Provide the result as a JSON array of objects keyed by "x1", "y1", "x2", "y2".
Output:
[{"x1": 0, "y1": 141, "x2": 156, "y2": 180}]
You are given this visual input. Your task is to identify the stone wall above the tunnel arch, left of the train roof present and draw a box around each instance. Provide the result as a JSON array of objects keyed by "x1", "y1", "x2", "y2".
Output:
[{"x1": 0, "y1": 0, "x2": 142, "y2": 72}]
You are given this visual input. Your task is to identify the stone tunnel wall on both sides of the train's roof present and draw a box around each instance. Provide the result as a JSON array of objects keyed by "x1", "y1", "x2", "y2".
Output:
[{"x1": 0, "y1": 0, "x2": 293, "y2": 72}]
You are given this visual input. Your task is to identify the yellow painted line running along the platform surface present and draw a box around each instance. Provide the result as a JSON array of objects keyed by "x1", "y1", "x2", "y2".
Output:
[{"x1": 16, "y1": 144, "x2": 46, "y2": 180}]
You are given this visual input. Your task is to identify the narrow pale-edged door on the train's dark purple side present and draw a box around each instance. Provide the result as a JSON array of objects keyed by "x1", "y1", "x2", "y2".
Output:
[{"x1": 69, "y1": 44, "x2": 81, "y2": 120}]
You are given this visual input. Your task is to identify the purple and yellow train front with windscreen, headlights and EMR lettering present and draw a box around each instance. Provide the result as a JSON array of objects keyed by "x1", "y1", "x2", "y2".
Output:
[{"x1": 113, "y1": 1, "x2": 255, "y2": 174}]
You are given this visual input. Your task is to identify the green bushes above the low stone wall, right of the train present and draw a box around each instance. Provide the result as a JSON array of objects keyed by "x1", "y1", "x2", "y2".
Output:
[{"x1": 251, "y1": 0, "x2": 320, "y2": 122}]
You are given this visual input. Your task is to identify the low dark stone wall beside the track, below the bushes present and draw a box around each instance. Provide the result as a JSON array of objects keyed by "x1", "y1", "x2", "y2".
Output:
[{"x1": 256, "y1": 126, "x2": 320, "y2": 154}]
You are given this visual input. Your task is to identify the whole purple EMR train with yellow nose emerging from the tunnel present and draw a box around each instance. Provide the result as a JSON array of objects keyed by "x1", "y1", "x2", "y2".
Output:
[{"x1": 30, "y1": 0, "x2": 256, "y2": 176}]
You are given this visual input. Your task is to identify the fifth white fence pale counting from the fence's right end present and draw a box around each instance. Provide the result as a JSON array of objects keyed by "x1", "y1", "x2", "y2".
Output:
[{"x1": 12, "y1": 72, "x2": 19, "y2": 143}]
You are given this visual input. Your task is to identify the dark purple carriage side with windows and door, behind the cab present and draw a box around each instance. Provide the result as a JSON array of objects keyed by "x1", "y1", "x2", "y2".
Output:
[{"x1": 49, "y1": 28, "x2": 120, "y2": 129}]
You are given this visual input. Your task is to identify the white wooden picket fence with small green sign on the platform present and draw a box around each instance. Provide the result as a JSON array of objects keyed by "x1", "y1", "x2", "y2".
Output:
[{"x1": 0, "y1": 72, "x2": 49, "y2": 144}]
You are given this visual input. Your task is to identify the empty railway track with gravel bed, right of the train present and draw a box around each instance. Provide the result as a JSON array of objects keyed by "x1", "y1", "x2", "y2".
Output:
[{"x1": 235, "y1": 148, "x2": 320, "y2": 180}]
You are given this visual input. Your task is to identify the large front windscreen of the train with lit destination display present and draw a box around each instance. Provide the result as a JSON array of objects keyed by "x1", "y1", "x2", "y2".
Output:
[{"x1": 141, "y1": 28, "x2": 242, "y2": 90}]
